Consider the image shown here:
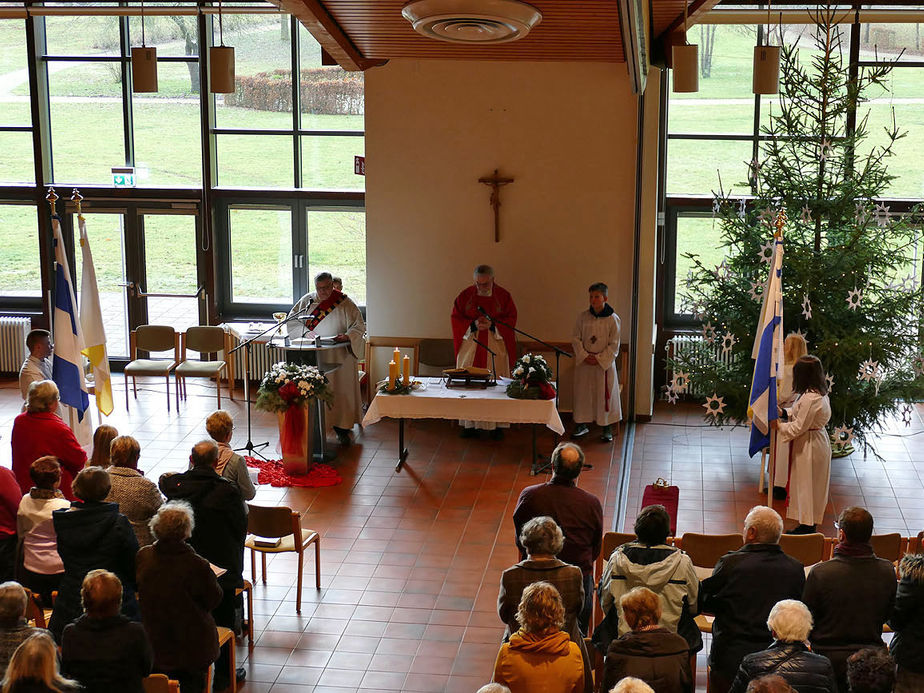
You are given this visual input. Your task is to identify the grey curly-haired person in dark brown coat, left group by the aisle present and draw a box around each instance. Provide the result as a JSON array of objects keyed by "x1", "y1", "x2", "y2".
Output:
[{"x1": 137, "y1": 501, "x2": 222, "y2": 693}]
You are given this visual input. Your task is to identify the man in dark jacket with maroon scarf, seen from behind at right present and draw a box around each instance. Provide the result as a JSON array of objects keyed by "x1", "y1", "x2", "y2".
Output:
[{"x1": 802, "y1": 507, "x2": 897, "y2": 693}]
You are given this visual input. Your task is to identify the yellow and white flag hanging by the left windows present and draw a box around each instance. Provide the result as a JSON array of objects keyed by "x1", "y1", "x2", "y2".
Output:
[{"x1": 77, "y1": 214, "x2": 112, "y2": 416}]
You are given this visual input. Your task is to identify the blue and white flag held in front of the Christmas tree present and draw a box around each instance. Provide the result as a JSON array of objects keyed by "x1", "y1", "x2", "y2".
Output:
[{"x1": 748, "y1": 237, "x2": 783, "y2": 456}]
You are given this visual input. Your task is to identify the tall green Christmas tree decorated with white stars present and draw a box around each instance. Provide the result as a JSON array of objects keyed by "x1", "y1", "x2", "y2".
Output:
[{"x1": 667, "y1": 11, "x2": 924, "y2": 443}]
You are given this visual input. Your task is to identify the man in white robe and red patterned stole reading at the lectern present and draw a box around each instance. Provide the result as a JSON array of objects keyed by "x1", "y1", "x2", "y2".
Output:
[{"x1": 287, "y1": 272, "x2": 366, "y2": 445}]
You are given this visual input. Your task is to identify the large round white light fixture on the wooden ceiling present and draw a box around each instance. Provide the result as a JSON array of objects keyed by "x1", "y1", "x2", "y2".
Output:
[{"x1": 401, "y1": 0, "x2": 542, "y2": 44}]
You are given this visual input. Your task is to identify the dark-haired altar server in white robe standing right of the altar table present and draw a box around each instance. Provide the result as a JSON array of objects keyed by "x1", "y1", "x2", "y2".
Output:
[{"x1": 571, "y1": 282, "x2": 622, "y2": 443}]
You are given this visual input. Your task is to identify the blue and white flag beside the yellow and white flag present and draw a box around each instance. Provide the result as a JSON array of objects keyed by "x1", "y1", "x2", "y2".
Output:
[{"x1": 51, "y1": 216, "x2": 90, "y2": 421}]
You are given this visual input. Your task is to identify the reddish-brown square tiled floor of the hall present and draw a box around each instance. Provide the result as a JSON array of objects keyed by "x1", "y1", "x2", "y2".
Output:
[{"x1": 0, "y1": 375, "x2": 924, "y2": 693}]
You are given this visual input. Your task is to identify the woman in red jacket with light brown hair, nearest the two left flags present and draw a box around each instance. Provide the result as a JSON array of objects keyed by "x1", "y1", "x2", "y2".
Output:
[{"x1": 10, "y1": 380, "x2": 87, "y2": 500}]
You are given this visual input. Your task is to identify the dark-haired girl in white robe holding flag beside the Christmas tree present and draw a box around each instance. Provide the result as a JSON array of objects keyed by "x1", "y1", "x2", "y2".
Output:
[{"x1": 770, "y1": 356, "x2": 831, "y2": 534}]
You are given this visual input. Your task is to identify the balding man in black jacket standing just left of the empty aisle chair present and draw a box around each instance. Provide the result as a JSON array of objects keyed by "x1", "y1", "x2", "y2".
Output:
[{"x1": 160, "y1": 440, "x2": 247, "y2": 690}]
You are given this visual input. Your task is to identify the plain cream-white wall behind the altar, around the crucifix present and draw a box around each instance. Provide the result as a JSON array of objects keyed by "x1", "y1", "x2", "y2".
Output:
[{"x1": 366, "y1": 60, "x2": 637, "y2": 406}]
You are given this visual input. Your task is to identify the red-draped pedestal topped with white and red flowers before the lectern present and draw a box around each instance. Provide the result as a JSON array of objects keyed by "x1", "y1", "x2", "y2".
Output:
[{"x1": 254, "y1": 362, "x2": 334, "y2": 474}]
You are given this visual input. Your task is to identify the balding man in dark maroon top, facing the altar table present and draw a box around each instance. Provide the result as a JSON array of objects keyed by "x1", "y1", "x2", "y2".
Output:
[{"x1": 513, "y1": 443, "x2": 603, "y2": 635}]
